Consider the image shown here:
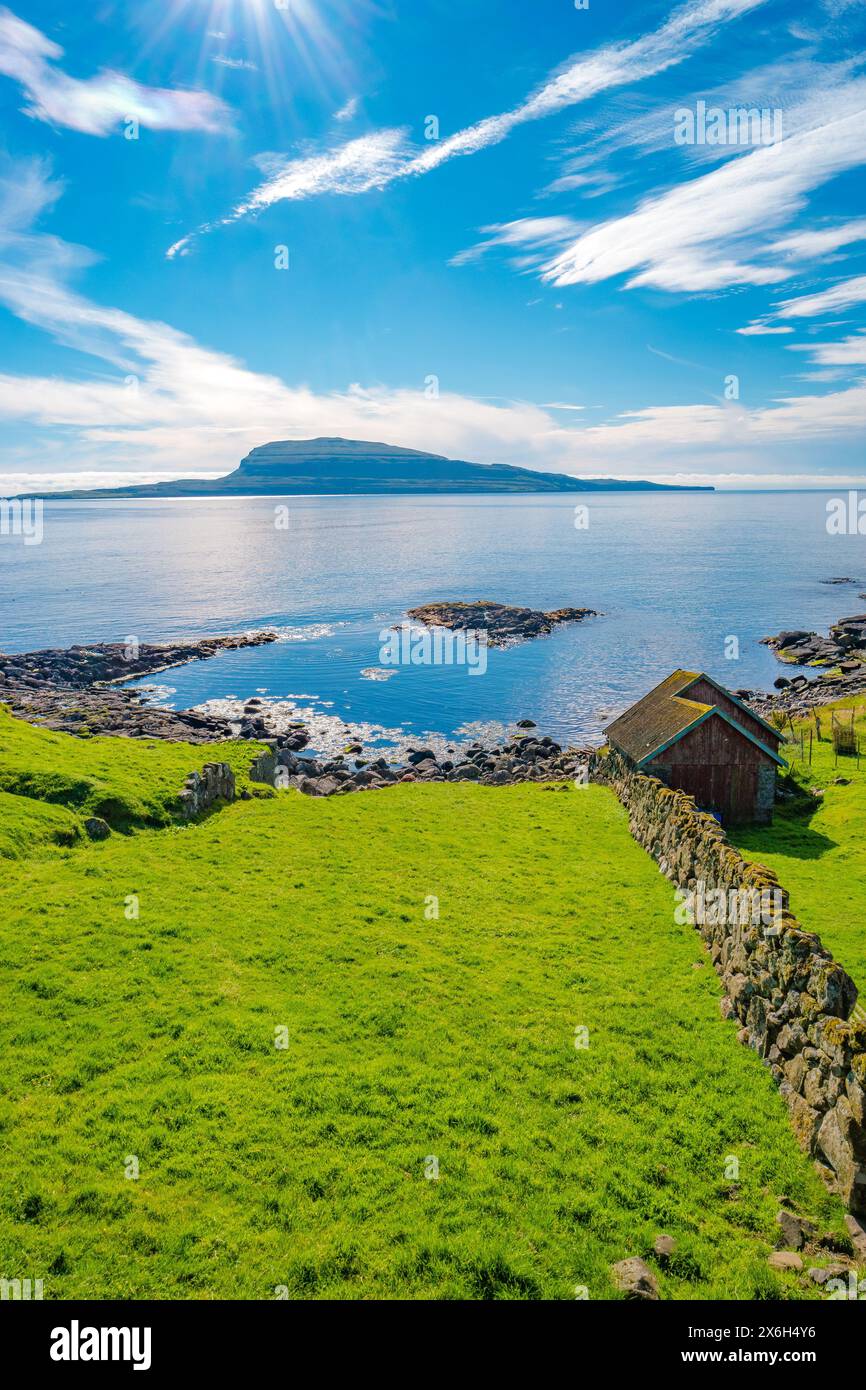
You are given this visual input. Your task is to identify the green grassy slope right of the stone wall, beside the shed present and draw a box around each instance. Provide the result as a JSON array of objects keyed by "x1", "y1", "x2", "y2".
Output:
[{"x1": 731, "y1": 695, "x2": 866, "y2": 1004}]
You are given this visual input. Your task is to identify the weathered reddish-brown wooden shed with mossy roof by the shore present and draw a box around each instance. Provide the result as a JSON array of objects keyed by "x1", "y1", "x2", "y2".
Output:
[{"x1": 605, "y1": 671, "x2": 785, "y2": 824}]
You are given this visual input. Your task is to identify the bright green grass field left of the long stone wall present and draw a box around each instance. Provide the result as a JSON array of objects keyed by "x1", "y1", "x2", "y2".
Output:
[{"x1": 0, "y1": 719, "x2": 842, "y2": 1300}]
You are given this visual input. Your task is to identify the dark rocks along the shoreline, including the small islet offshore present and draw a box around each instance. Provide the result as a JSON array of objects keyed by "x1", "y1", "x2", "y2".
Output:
[{"x1": 0, "y1": 602, "x2": 866, "y2": 778}]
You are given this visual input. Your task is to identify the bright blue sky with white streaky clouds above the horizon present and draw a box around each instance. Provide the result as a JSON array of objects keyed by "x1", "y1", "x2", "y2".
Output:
[{"x1": 0, "y1": 0, "x2": 866, "y2": 493}]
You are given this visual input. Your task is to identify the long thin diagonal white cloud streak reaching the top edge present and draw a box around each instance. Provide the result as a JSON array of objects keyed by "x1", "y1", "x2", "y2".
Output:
[{"x1": 167, "y1": 0, "x2": 765, "y2": 259}]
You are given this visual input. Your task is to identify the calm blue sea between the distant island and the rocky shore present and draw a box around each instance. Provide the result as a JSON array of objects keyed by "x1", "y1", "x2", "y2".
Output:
[{"x1": 0, "y1": 493, "x2": 866, "y2": 739}]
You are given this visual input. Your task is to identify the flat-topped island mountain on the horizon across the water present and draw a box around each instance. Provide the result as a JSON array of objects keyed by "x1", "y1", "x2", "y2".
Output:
[{"x1": 16, "y1": 439, "x2": 713, "y2": 498}]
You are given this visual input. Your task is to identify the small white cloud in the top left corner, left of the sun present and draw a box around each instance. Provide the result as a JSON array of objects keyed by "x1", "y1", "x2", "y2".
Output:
[{"x1": 0, "y1": 8, "x2": 231, "y2": 135}]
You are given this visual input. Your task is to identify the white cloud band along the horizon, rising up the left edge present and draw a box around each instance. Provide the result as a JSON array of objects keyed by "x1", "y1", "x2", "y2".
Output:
[{"x1": 0, "y1": 150, "x2": 866, "y2": 493}]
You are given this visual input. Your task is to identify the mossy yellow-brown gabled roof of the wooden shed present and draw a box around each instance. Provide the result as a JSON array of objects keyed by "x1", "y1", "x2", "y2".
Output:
[{"x1": 605, "y1": 670, "x2": 785, "y2": 767}]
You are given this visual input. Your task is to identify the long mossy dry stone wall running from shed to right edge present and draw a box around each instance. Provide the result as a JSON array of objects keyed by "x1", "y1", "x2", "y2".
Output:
[{"x1": 589, "y1": 749, "x2": 866, "y2": 1213}]
